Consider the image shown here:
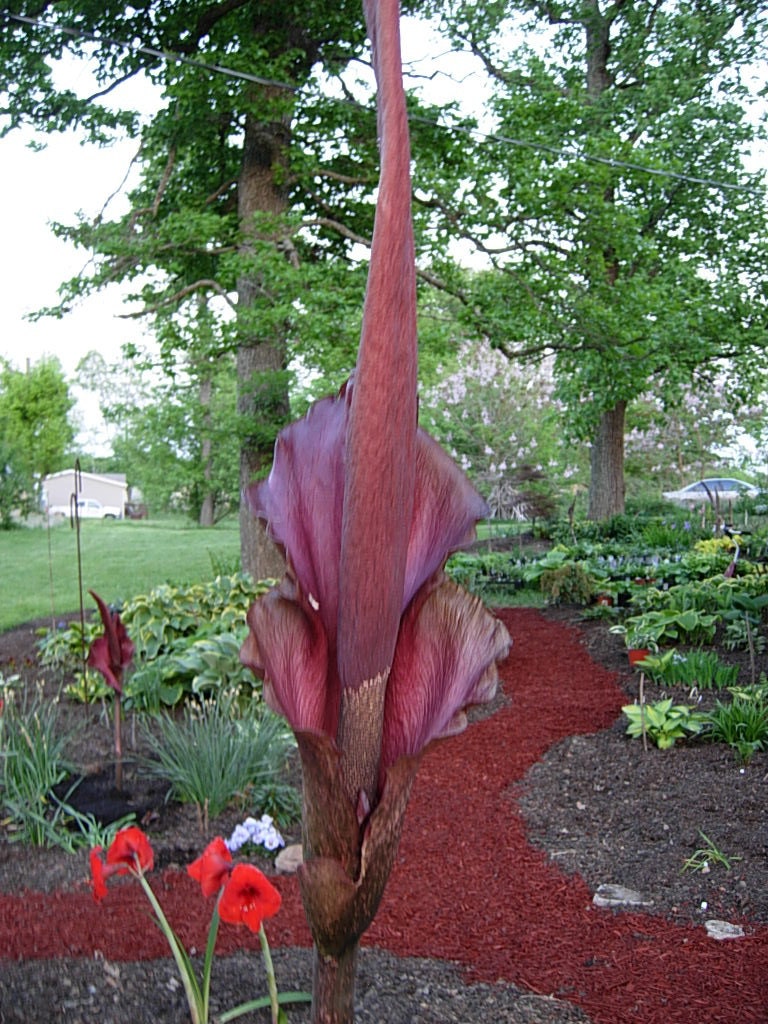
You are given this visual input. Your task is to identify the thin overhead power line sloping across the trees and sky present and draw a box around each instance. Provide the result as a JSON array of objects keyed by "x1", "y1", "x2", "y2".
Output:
[{"x1": 5, "y1": 11, "x2": 765, "y2": 196}]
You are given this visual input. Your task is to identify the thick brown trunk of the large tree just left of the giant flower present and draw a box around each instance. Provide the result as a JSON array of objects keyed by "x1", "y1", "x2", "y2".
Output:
[{"x1": 238, "y1": 103, "x2": 290, "y2": 580}]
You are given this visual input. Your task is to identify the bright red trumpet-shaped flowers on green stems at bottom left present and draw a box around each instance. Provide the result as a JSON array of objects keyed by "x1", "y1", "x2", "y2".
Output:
[{"x1": 90, "y1": 825, "x2": 308, "y2": 1024}]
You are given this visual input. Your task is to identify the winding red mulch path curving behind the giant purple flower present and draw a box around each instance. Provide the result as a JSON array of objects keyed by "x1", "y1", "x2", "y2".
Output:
[{"x1": 0, "y1": 608, "x2": 768, "y2": 1024}]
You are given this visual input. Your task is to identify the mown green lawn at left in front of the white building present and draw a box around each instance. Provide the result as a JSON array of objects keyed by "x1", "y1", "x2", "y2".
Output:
[{"x1": 0, "y1": 517, "x2": 240, "y2": 631}]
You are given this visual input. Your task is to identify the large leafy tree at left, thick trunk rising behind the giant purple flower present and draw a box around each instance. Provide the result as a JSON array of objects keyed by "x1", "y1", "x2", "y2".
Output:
[{"x1": 0, "y1": 0, "x2": 442, "y2": 575}]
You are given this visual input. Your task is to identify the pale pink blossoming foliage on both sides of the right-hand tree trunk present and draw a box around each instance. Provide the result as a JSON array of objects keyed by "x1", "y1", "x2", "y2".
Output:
[{"x1": 420, "y1": 341, "x2": 763, "y2": 509}]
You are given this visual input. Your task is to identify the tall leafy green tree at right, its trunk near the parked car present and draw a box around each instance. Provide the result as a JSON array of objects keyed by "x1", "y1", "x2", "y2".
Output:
[{"x1": 434, "y1": 0, "x2": 768, "y2": 519}]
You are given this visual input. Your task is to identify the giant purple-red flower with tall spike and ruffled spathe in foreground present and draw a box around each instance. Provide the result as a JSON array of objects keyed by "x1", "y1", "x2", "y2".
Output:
[{"x1": 242, "y1": 0, "x2": 510, "y2": 1024}]
